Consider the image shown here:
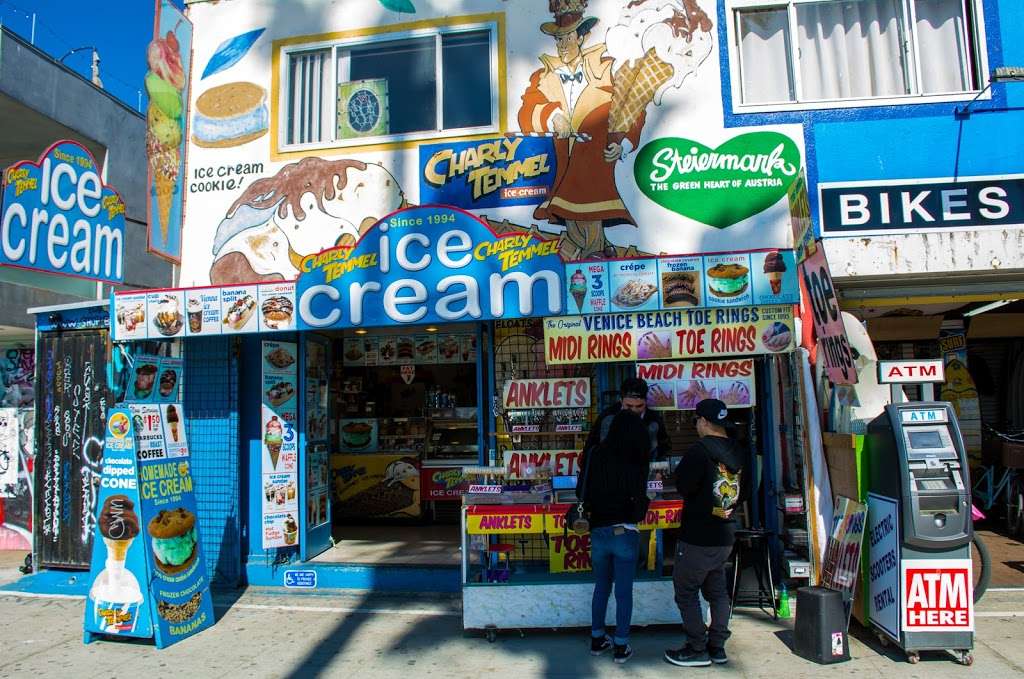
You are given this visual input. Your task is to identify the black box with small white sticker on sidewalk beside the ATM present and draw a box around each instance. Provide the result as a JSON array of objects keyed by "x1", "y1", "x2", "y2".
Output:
[{"x1": 793, "y1": 587, "x2": 850, "y2": 665}]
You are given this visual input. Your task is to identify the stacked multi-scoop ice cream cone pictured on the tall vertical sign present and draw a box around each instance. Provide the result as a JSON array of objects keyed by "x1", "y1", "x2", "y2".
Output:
[{"x1": 145, "y1": 24, "x2": 185, "y2": 246}]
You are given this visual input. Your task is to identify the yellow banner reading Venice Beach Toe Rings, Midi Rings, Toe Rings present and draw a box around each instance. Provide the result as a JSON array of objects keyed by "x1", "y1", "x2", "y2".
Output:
[{"x1": 544, "y1": 305, "x2": 796, "y2": 366}]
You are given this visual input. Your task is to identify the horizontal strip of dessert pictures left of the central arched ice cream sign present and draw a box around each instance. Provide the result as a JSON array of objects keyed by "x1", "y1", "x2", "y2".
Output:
[{"x1": 111, "y1": 282, "x2": 295, "y2": 342}]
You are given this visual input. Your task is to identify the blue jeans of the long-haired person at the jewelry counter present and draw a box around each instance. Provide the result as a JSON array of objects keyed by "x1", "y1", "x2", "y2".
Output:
[{"x1": 590, "y1": 525, "x2": 640, "y2": 646}]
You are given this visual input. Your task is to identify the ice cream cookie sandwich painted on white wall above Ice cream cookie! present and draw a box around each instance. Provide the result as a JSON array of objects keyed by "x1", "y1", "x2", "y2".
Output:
[{"x1": 191, "y1": 82, "x2": 270, "y2": 148}]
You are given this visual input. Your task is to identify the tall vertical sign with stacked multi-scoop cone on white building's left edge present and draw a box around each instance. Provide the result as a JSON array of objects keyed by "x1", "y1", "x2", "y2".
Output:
[{"x1": 145, "y1": 0, "x2": 193, "y2": 263}]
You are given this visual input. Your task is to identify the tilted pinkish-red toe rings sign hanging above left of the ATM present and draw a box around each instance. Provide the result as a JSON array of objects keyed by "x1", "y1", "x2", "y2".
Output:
[{"x1": 800, "y1": 244, "x2": 857, "y2": 384}]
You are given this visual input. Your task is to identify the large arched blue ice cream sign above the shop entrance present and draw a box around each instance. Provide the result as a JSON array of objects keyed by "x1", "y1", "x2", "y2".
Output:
[{"x1": 296, "y1": 206, "x2": 562, "y2": 330}]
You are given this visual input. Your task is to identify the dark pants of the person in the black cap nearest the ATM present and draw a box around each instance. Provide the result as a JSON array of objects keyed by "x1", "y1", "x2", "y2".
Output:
[{"x1": 672, "y1": 542, "x2": 732, "y2": 652}]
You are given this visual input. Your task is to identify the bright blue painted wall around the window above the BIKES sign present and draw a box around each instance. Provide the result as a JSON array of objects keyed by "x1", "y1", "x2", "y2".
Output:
[{"x1": 719, "y1": 0, "x2": 1024, "y2": 231}]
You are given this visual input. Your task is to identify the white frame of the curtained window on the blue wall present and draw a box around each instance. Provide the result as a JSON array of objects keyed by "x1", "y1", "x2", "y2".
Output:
[{"x1": 725, "y1": 0, "x2": 992, "y2": 114}]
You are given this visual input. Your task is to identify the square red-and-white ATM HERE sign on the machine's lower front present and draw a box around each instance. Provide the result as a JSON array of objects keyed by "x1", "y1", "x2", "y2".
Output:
[{"x1": 900, "y1": 559, "x2": 974, "y2": 632}]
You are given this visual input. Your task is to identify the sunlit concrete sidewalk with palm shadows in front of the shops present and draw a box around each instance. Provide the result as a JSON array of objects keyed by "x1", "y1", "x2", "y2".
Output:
[{"x1": 0, "y1": 577, "x2": 1024, "y2": 679}]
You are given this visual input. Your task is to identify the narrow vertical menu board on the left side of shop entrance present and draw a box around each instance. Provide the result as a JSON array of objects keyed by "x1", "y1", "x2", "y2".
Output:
[{"x1": 260, "y1": 342, "x2": 299, "y2": 549}]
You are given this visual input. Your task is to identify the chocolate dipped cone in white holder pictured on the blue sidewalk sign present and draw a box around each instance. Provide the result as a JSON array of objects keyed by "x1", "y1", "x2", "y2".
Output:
[{"x1": 89, "y1": 495, "x2": 143, "y2": 634}]
